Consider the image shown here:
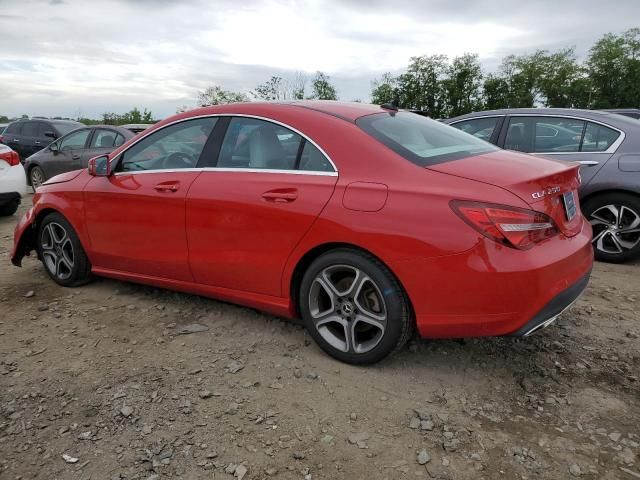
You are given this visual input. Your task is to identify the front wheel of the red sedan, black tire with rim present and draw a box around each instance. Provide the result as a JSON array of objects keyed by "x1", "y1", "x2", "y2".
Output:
[{"x1": 36, "y1": 213, "x2": 91, "y2": 287}]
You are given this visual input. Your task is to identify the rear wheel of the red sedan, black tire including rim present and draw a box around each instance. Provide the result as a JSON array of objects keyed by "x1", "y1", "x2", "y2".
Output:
[{"x1": 298, "y1": 249, "x2": 414, "y2": 365}]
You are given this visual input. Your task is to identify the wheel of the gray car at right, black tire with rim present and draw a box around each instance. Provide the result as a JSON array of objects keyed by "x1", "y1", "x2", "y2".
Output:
[{"x1": 582, "y1": 193, "x2": 640, "y2": 263}]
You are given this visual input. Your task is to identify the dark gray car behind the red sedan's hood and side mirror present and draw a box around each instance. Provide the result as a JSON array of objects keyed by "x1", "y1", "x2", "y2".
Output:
[{"x1": 24, "y1": 125, "x2": 135, "y2": 190}]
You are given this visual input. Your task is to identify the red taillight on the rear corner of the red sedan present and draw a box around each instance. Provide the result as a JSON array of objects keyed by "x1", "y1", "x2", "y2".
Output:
[{"x1": 451, "y1": 200, "x2": 558, "y2": 250}]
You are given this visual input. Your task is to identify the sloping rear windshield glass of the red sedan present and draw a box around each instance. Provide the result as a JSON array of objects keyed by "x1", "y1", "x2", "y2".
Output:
[{"x1": 356, "y1": 112, "x2": 498, "y2": 167}]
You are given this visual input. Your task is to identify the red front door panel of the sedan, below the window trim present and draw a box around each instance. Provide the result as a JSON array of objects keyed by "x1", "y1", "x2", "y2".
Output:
[{"x1": 85, "y1": 170, "x2": 200, "y2": 281}]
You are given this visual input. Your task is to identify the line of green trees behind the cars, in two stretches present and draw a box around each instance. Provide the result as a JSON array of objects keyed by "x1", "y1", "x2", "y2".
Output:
[{"x1": 188, "y1": 28, "x2": 640, "y2": 118}]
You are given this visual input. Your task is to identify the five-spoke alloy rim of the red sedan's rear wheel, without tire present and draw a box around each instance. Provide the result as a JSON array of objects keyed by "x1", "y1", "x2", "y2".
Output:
[{"x1": 308, "y1": 265, "x2": 387, "y2": 354}]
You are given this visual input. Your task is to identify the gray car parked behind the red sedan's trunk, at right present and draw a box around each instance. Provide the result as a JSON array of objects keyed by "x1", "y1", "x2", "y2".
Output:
[{"x1": 445, "y1": 108, "x2": 640, "y2": 262}]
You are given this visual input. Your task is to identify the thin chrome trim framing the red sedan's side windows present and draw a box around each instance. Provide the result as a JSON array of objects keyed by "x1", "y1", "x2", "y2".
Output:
[{"x1": 109, "y1": 113, "x2": 338, "y2": 177}]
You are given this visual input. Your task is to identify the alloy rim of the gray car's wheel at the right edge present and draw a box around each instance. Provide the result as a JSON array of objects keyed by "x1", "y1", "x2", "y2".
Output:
[{"x1": 589, "y1": 204, "x2": 640, "y2": 255}]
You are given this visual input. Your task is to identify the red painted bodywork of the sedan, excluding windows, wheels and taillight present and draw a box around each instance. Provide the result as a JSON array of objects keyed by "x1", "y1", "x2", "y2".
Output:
[{"x1": 12, "y1": 102, "x2": 593, "y2": 337}]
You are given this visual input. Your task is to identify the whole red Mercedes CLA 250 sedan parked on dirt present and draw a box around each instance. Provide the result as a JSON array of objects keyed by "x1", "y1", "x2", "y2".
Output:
[{"x1": 12, "y1": 101, "x2": 593, "y2": 363}]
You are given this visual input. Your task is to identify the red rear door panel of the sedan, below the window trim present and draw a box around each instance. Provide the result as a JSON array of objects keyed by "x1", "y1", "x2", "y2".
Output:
[{"x1": 186, "y1": 171, "x2": 337, "y2": 296}]
